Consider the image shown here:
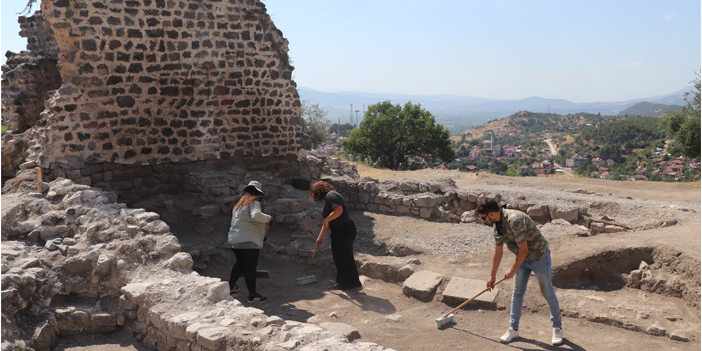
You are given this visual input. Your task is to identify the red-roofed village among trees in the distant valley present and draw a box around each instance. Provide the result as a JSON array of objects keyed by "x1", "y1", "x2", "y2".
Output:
[{"x1": 315, "y1": 118, "x2": 700, "y2": 182}]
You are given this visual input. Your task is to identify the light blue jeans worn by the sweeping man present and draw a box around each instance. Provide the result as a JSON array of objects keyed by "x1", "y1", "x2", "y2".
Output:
[{"x1": 509, "y1": 250, "x2": 561, "y2": 330}]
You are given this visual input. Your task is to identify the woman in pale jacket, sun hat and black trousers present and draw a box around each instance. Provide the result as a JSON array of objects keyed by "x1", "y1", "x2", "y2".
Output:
[{"x1": 227, "y1": 180, "x2": 271, "y2": 302}]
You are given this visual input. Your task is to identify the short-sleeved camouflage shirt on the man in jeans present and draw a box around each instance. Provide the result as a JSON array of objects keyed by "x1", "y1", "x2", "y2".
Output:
[{"x1": 492, "y1": 209, "x2": 548, "y2": 260}]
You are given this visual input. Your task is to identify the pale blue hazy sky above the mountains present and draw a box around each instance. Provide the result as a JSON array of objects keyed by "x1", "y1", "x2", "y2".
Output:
[{"x1": 0, "y1": 0, "x2": 702, "y2": 102}]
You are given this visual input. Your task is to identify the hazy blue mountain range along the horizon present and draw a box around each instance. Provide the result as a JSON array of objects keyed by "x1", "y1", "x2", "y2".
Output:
[{"x1": 298, "y1": 86, "x2": 694, "y2": 130}]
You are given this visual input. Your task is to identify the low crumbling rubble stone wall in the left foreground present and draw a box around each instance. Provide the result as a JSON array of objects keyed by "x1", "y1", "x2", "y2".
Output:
[{"x1": 2, "y1": 179, "x2": 390, "y2": 351}]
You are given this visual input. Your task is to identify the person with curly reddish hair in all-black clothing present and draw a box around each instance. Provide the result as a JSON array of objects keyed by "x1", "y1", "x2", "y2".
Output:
[{"x1": 310, "y1": 180, "x2": 363, "y2": 292}]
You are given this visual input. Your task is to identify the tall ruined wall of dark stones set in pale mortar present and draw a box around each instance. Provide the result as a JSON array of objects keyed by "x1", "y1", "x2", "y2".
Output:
[{"x1": 3, "y1": 0, "x2": 302, "y2": 199}]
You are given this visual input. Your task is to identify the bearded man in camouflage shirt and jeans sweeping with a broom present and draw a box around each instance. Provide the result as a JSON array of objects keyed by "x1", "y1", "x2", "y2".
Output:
[{"x1": 476, "y1": 198, "x2": 563, "y2": 345}]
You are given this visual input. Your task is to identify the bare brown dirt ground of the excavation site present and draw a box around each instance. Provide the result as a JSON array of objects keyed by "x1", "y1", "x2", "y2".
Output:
[{"x1": 55, "y1": 166, "x2": 701, "y2": 351}]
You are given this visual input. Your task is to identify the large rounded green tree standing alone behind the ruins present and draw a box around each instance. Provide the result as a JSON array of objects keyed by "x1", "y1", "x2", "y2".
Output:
[{"x1": 343, "y1": 101, "x2": 456, "y2": 170}]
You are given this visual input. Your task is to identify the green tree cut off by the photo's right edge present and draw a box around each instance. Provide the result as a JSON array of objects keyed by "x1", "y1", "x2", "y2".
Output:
[{"x1": 661, "y1": 73, "x2": 702, "y2": 159}]
